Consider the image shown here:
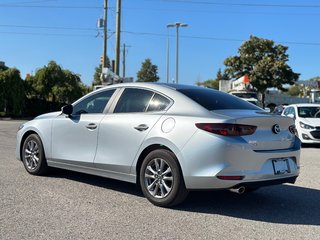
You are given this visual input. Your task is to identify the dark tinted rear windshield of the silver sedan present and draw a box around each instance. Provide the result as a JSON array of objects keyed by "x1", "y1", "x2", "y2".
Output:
[{"x1": 177, "y1": 88, "x2": 261, "y2": 111}]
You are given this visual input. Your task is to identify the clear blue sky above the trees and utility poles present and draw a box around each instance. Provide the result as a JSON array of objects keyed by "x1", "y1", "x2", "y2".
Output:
[{"x1": 0, "y1": 0, "x2": 320, "y2": 85}]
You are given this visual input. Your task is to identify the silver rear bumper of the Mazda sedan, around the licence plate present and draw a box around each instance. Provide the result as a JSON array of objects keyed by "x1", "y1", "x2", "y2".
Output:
[{"x1": 178, "y1": 131, "x2": 300, "y2": 190}]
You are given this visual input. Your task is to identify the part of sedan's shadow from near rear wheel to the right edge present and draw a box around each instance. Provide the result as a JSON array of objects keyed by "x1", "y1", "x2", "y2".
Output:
[{"x1": 177, "y1": 185, "x2": 320, "y2": 225}]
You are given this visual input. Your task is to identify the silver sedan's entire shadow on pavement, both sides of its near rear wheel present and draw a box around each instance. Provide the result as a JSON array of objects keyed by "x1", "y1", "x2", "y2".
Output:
[{"x1": 48, "y1": 169, "x2": 320, "y2": 225}]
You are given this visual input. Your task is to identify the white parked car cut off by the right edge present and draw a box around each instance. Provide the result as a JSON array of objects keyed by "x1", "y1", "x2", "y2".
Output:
[{"x1": 282, "y1": 103, "x2": 320, "y2": 143}]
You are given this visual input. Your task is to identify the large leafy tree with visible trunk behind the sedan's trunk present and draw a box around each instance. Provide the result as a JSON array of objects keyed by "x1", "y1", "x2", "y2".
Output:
[{"x1": 224, "y1": 36, "x2": 300, "y2": 104}]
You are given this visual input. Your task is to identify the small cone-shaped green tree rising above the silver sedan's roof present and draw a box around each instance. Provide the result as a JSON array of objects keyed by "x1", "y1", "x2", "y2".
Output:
[{"x1": 137, "y1": 58, "x2": 159, "y2": 82}]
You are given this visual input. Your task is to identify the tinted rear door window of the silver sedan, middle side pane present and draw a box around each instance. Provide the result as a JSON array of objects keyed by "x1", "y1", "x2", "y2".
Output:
[{"x1": 114, "y1": 88, "x2": 154, "y2": 113}]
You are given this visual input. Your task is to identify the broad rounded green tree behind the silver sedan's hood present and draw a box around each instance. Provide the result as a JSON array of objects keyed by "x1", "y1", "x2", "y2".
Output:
[{"x1": 26, "y1": 61, "x2": 88, "y2": 103}]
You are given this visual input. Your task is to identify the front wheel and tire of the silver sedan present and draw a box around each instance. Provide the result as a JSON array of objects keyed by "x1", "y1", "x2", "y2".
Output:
[{"x1": 21, "y1": 134, "x2": 48, "y2": 175}]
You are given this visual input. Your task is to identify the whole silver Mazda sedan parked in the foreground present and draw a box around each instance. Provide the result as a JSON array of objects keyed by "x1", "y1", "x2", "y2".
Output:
[{"x1": 16, "y1": 83, "x2": 300, "y2": 207}]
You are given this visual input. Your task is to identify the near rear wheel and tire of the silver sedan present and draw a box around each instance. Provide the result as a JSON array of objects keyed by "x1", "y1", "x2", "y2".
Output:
[{"x1": 139, "y1": 149, "x2": 188, "y2": 207}]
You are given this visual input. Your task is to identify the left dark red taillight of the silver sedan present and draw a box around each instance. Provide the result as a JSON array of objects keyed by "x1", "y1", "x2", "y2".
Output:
[{"x1": 196, "y1": 123, "x2": 257, "y2": 136}]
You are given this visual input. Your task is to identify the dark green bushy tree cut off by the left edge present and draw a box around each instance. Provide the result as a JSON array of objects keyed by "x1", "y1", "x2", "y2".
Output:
[{"x1": 0, "y1": 68, "x2": 25, "y2": 116}]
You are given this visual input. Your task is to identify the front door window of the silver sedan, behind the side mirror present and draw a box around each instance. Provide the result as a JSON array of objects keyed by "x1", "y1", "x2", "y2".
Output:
[{"x1": 73, "y1": 89, "x2": 115, "y2": 115}]
